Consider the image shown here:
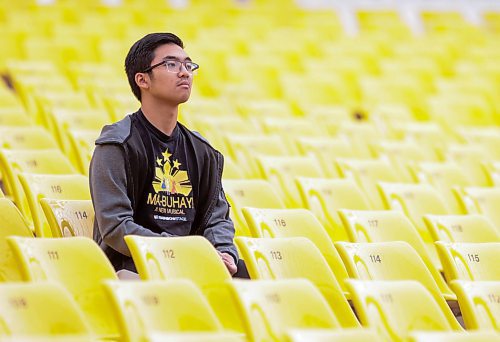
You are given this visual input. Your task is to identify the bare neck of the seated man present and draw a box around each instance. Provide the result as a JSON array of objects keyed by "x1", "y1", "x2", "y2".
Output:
[{"x1": 141, "y1": 99, "x2": 179, "y2": 136}]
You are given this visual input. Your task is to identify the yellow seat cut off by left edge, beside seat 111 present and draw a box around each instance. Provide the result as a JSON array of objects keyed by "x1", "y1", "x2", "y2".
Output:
[{"x1": 0, "y1": 198, "x2": 33, "y2": 282}]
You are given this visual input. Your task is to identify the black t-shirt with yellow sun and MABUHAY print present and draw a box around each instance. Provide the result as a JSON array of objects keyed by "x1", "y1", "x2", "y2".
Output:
[{"x1": 134, "y1": 112, "x2": 196, "y2": 236}]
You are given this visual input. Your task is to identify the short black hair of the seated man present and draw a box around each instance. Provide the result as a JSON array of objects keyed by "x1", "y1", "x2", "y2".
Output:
[{"x1": 125, "y1": 33, "x2": 184, "y2": 101}]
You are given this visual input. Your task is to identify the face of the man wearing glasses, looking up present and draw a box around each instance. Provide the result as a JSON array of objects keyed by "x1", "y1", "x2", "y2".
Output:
[{"x1": 136, "y1": 44, "x2": 193, "y2": 105}]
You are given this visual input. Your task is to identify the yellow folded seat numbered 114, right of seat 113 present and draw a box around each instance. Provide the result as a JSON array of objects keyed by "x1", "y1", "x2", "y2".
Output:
[{"x1": 335, "y1": 241, "x2": 462, "y2": 330}]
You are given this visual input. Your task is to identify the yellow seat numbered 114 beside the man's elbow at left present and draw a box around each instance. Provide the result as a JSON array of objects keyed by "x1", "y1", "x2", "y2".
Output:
[{"x1": 40, "y1": 198, "x2": 94, "y2": 238}]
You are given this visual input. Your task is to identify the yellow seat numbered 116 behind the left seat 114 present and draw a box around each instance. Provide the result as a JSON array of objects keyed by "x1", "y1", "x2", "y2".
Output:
[{"x1": 19, "y1": 173, "x2": 90, "y2": 237}]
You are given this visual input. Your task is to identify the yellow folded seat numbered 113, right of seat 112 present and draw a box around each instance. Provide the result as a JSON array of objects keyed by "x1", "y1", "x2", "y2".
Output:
[{"x1": 236, "y1": 237, "x2": 359, "y2": 327}]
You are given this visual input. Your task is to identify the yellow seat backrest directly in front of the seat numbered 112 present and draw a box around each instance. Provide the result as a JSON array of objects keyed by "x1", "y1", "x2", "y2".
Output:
[{"x1": 105, "y1": 279, "x2": 244, "y2": 342}]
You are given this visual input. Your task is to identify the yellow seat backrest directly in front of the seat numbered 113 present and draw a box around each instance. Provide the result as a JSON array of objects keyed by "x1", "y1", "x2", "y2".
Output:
[{"x1": 232, "y1": 279, "x2": 340, "y2": 341}]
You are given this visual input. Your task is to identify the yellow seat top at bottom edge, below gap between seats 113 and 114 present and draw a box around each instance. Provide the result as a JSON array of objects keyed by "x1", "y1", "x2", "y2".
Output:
[{"x1": 287, "y1": 329, "x2": 381, "y2": 342}]
